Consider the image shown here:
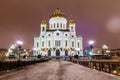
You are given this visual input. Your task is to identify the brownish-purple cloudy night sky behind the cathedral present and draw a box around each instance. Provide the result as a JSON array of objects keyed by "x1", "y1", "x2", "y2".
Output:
[{"x1": 0, "y1": 0, "x2": 120, "y2": 48}]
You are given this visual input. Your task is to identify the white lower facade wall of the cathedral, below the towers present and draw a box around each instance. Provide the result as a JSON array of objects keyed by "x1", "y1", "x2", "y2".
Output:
[{"x1": 34, "y1": 31, "x2": 83, "y2": 56}]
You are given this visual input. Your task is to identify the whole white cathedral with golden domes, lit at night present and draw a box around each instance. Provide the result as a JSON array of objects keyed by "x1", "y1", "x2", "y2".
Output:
[{"x1": 34, "y1": 9, "x2": 83, "y2": 56}]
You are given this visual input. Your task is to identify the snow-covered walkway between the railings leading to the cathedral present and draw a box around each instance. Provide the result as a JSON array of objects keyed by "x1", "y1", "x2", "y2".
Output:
[{"x1": 0, "y1": 60, "x2": 120, "y2": 80}]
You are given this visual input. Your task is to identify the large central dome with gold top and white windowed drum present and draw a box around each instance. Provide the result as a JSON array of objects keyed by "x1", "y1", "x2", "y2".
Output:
[{"x1": 49, "y1": 8, "x2": 67, "y2": 29}]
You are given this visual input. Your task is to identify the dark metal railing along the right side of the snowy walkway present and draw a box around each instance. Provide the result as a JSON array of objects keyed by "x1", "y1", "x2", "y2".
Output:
[{"x1": 67, "y1": 57, "x2": 120, "y2": 76}]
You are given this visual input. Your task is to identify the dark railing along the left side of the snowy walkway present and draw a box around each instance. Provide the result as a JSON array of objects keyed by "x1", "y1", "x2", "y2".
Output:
[{"x1": 0, "y1": 58, "x2": 49, "y2": 72}]
